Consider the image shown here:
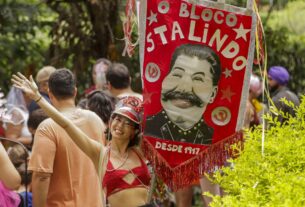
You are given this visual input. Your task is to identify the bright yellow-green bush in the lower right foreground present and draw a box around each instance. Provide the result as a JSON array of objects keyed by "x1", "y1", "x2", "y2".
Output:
[{"x1": 211, "y1": 97, "x2": 305, "y2": 207}]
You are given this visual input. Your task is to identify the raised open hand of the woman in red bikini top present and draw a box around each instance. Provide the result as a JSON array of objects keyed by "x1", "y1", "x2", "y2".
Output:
[{"x1": 11, "y1": 72, "x2": 41, "y2": 100}]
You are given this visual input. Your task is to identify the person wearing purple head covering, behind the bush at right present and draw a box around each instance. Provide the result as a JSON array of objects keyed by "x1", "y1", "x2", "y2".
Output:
[{"x1": 268, "y1": 66, "x2": 300, "y2": 123}]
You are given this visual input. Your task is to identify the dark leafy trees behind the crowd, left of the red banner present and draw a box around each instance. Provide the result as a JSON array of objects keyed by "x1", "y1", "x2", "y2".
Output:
[{"x1": 0, "y1": 0, "x2": 123, "y2": 95}]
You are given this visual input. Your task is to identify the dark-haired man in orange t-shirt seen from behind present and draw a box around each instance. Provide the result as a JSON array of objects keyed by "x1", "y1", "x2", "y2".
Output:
[{"x1": 29, "y1": 69, "x2": 105, "y2": 207}]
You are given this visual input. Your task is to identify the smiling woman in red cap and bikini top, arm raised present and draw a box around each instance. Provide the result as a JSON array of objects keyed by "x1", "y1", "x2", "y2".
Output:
[{"x1": 12, "y1": 73, "x2": 150, "y2": 207}]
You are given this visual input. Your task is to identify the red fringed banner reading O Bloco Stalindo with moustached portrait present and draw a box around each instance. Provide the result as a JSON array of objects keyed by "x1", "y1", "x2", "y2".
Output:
[{"x1": 139, "y1": 0, "x2": 255, "y2": 190}]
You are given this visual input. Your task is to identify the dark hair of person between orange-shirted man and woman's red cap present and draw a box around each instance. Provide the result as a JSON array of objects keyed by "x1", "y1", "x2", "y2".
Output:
[{"x1": 87, "y1": 90, "x2": 116, "y2": 124}]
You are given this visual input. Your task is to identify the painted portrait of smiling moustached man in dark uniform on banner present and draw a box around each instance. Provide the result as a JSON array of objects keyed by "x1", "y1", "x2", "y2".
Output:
[{"x1": 144, "y1": 44, "x2": 221, "y2": 145}]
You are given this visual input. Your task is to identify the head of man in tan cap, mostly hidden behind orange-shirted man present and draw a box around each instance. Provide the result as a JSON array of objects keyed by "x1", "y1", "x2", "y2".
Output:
[{"x1": 28, "y1": 66, "x2": 56, "y2": 114}]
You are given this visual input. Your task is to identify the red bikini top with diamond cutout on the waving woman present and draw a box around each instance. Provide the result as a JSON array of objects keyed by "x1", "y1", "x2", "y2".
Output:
[{"x1": 103, "y1": 150, "x2": 150, "y2": 198}]
